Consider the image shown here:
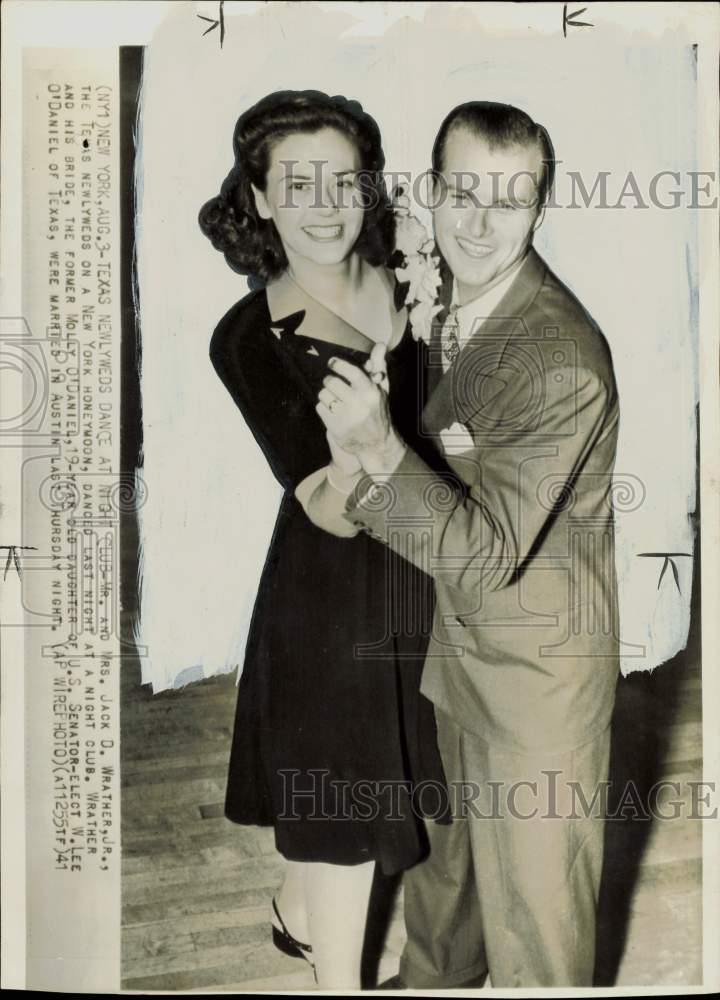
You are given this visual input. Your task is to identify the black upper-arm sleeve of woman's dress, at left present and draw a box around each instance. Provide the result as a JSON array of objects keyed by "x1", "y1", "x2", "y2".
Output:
[{"x1": 210, "y1": 312, "x2": 330, "y2": 490}]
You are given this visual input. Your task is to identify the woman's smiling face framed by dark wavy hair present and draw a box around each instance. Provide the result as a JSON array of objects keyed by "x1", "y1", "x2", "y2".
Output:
[{"x1": 253, "y1": 128, "x2": 364, "y2": 265}]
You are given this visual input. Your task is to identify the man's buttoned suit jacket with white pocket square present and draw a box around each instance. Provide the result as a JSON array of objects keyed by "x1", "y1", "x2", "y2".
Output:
[{"x1": 345, "y1": 249, "x2": 619, "y2": 753}]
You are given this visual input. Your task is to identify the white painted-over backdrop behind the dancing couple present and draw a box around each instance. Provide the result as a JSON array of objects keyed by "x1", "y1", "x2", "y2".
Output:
[{"x1": 138, "y1": 4, "x2": 700, "y2": 690}]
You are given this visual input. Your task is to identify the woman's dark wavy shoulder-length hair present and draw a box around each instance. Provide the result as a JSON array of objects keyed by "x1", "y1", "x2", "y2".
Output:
[{"x1": 198, "y1": 90, "x2": 395, "y2": 281}]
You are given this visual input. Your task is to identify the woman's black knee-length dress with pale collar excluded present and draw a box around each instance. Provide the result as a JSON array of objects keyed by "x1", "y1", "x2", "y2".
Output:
[{"x1": 210, "y1": 282, "x2": 444, "y2": 874}]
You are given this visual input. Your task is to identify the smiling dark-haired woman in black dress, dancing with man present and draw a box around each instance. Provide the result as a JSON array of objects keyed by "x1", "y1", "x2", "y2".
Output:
[{"x1": 200, "y1": 91, "x2": 443, "y2": 989}]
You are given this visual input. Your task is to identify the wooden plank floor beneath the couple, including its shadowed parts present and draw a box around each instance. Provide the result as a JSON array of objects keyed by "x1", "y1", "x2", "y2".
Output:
[{"x1": 122, "y1": 568, "x2": 702, "y2": 992}]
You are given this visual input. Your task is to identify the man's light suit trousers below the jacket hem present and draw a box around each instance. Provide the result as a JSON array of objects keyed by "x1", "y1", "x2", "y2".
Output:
[{"x1": 400, "y1": 709, "x2": 610, "y2": 989}]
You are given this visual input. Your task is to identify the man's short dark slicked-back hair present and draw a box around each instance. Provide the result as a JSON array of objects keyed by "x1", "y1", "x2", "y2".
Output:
[{"x1": 432, "y1": 101, "x2": 555, "y2": 205}]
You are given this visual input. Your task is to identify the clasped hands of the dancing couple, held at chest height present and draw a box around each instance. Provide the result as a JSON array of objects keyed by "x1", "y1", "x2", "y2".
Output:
[{"x1": 315, "y1": 344, "x2": 405, "y2": 474}]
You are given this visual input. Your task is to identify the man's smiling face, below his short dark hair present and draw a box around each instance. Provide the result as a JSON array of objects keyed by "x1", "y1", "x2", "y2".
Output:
[{"x1": 433, "y1": 126, "x2": 543, "y2": 305}]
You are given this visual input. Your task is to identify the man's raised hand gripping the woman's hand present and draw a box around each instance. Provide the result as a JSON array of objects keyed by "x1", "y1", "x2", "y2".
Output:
[{"x1": 315, "y1": 358, "x2": 392, "y2": 461}]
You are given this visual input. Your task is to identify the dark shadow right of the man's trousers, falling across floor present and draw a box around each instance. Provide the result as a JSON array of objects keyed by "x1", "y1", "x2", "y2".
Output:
[{"x1": 595, "y1": 545, "x2": 700, "y2": 986}]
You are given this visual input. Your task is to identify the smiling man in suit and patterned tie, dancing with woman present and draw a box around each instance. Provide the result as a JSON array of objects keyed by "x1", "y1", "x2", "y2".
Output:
[{"x1": 318, "y1": 102, "x2": 618, "y2": 988}]
